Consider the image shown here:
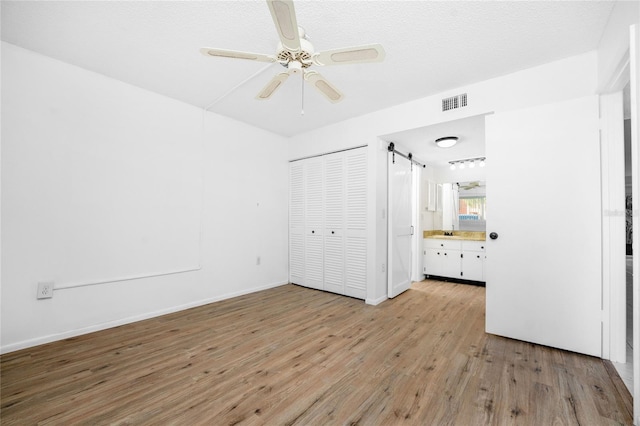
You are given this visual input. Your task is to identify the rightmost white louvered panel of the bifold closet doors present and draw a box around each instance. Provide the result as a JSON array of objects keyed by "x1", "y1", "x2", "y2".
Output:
[{"x1": 344, "y1": 148, "x2": 367, "y2": 299}]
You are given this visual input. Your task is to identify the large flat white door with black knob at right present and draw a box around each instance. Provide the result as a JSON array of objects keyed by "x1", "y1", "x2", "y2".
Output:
[{"x1": 486, "y1": 96, "x2": 602, "y2": 356}]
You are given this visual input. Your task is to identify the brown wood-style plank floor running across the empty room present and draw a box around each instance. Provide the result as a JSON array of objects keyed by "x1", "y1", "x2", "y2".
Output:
[{"x1": 0, "y1": 281, "x2": 632, "y2": 426}]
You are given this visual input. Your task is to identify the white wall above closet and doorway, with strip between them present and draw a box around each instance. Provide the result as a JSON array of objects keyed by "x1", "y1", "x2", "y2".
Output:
[{"x1": 289, "y1": 52, "x2": 598, "y2": 303}]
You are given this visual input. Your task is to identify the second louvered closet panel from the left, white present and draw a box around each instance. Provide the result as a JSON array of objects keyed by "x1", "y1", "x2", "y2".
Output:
[{"x1": 304, "y1": 157, "x2": 324, "y2": 290}]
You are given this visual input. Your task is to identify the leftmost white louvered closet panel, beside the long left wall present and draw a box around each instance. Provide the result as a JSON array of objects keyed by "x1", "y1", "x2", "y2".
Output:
[{"x1": 289, "y1": 161, "x2": 305, "y2": 285}]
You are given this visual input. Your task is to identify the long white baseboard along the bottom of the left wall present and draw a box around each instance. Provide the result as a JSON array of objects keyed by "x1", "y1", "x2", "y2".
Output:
[{"x1": 0, "y1": 281, "x2": 289, "y2": 354}]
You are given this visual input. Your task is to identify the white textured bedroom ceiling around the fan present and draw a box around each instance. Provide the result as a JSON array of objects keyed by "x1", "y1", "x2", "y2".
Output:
[{"x1": 1, "y1": 0, "x2": 613, "y2": 135}]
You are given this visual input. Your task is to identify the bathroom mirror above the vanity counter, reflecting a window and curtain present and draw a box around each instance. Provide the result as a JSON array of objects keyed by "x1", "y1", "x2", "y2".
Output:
[{"x1": 442, "y1": 181, "x2": 487, "y2": 232}]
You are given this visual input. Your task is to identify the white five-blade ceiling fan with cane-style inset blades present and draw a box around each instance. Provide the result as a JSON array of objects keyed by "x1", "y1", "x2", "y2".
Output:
[{"x1": 200, "y1": 0, "x2": 385, "y2": 103}]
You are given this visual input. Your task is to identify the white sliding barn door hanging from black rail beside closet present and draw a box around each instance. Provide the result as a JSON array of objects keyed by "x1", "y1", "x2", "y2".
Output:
[{"x1": 387, "y1": 153, "x2": 413, "y2": 298}]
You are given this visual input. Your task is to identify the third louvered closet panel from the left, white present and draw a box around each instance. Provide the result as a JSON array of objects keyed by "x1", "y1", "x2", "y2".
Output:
[{"x1": 324, "y1": 152, "x2": 345, "y2": 294}]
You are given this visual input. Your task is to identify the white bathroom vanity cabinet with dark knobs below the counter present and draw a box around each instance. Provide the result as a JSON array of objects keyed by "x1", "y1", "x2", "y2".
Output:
[{"x1": 422, "y1": 238, "x2": 486, "y2": 282}]
